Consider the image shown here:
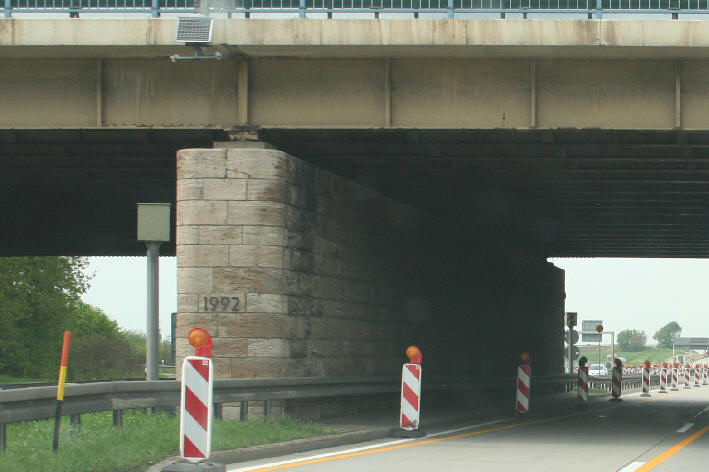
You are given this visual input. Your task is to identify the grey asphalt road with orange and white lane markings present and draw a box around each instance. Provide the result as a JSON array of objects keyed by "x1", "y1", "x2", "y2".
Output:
[{"x1": 227, "y1": 386, "x2": 709, "y2": 472}]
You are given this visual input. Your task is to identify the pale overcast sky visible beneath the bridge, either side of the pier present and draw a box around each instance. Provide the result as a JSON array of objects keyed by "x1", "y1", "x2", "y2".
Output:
[{"x1": 83, "y1": 257, "x2": 709, "y2": 342}]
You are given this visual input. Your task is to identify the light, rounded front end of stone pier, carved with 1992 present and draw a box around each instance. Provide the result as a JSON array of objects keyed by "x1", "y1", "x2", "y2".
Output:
[{"x1": 176, "y1": 149, "x2": 307, "y2": 379}]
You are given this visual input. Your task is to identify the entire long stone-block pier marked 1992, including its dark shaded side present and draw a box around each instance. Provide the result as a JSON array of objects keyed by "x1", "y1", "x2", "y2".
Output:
[{"x1": 176, "y1": 143, "x2": 564, "y2": 416}]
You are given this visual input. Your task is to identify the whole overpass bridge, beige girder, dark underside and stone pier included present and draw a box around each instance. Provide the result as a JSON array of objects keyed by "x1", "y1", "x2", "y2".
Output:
[{"x1": 0, "y1": 18, "x2": 709, "y2": 412}]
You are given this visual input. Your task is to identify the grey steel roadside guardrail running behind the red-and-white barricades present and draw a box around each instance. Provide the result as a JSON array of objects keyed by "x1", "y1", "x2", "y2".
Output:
[{"x1": 0, "y1": 374, "x2": 656, "y2": 450}]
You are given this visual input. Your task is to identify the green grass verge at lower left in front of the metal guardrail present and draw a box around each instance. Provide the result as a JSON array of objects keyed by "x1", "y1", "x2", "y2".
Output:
[{"x1": 0, "y1": 411, "x2": 326, "y2": 472}]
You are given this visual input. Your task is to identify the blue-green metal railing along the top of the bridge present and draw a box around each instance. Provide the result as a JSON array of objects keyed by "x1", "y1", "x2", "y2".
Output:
[{"x1": 0, "y1": 0, "x2": 709, "y2": 19}]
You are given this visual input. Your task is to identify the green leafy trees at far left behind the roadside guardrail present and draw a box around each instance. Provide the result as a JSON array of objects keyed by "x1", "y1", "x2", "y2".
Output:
[{"x1": 0, "y1": 257, "x2": 170, "y2": 380}]
